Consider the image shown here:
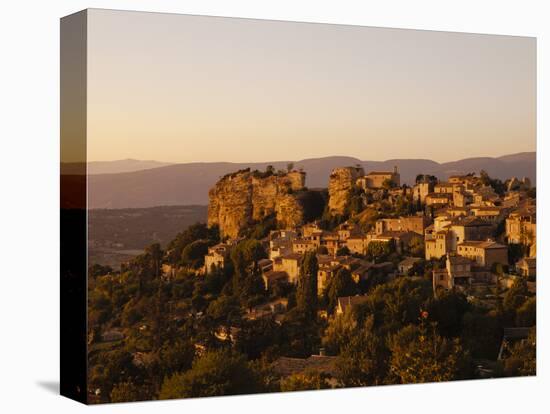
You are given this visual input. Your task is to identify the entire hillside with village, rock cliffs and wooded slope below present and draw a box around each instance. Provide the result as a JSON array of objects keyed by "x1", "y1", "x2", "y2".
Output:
[{"x1": 88, "y1": 164, "x2": 536, "y2": 401}]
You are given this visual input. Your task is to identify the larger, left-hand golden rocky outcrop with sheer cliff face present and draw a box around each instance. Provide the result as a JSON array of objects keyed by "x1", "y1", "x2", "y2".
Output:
[{"x1": 208, "y1": 170, "x2": 305, "y2": 238}]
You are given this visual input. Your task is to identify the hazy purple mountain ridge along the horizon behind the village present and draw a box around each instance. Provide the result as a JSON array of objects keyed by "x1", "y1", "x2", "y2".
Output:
[{"x1": 78, "y1": 152, "x2": 536, "y2": 208}]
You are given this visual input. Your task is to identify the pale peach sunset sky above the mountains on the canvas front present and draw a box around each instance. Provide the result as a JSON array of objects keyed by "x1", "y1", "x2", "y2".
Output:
[{"x1": 87, "y1": 9, "x2": 536, "y2": 162}]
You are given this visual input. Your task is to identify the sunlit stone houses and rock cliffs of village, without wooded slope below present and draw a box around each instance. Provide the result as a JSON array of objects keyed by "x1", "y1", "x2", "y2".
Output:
[{"x1": 203, "y1": 167, "x2": 536, "y2": 300}]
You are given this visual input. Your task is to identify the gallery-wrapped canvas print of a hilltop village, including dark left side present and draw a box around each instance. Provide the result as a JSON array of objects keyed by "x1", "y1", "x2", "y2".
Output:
[{"x1": 60, "y1": 9, "x2": 537, "y2": 404}]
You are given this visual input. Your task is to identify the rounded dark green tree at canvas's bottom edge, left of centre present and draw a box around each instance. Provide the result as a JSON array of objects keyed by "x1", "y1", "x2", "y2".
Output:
[{"x1": 159, "y1": 349, "x2": 262, "y2": 399}]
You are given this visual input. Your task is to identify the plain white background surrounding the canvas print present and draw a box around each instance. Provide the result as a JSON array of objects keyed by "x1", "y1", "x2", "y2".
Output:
[{"x1": 0, "y1": 0, "x2": 550, "y2": 414}]
